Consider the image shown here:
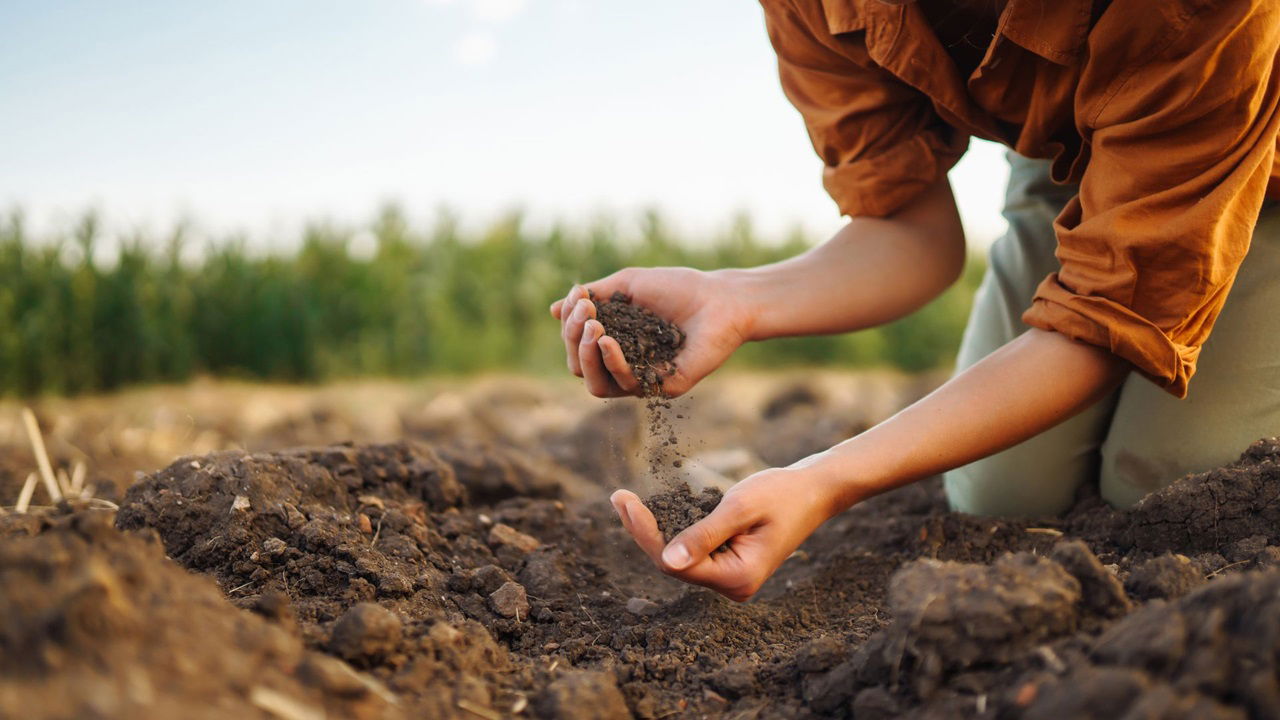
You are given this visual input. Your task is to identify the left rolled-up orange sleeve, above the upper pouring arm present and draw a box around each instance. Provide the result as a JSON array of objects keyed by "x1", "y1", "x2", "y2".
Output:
[{"x1": 760, "y1": 0, "x2": 969, "y2": 217}]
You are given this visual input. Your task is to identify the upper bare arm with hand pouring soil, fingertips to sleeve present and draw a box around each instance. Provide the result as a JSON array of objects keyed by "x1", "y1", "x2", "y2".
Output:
[{"x1": 550, "y1": 178, "x2": 965, "y2": 397}]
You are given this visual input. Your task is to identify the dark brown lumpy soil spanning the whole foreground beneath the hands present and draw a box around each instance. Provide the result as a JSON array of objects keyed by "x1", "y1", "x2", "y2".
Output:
[{"x1": 0, "y1": 384, "x2": 1280, "y2": 720}]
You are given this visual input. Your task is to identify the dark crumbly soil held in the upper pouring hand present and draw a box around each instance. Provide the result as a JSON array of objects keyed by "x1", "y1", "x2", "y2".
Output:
[{"x1": 591, "y1": 292, "x2": 685, "y2": 397}]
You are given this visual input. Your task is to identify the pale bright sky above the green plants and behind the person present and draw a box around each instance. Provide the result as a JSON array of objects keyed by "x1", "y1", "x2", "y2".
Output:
[{"x1": 0, "y1": 0, "x2": 1007, "y2": 245}]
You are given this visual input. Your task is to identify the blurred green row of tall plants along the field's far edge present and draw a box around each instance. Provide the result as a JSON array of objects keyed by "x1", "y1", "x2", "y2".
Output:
[{"x1": 0, "y1": 208, "x2": 982, "y2": 395}]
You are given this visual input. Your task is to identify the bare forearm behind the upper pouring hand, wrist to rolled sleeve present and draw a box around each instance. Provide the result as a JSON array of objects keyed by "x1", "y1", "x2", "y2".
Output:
[{"x1": 727, "y1": 179, "x2": 965, "y2": 340}]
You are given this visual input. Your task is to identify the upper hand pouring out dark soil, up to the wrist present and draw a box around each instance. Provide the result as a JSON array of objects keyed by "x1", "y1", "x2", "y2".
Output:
[{"x1": 550, "y1": 268, "x2": 754, "y2": 397}]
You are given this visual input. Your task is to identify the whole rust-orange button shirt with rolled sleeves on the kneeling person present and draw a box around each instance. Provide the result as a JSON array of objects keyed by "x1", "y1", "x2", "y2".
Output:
[{"x1": 760, "y1": 0, "x2": 1280, "y2": 397}]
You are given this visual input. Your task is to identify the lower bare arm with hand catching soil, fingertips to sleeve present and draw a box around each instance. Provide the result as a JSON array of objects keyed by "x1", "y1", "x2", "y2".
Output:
[{"x1": 613, "y1": 329, "x2": 1129, "y2": 600}]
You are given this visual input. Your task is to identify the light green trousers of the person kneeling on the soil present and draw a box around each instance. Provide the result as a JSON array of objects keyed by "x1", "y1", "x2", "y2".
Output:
[{"x1": 945, "y1": 154, "x2": 1280, "y2": 516}]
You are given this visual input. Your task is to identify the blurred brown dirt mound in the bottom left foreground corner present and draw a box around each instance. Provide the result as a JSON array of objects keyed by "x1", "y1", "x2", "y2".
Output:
[{"x1": 0, "y1": 511, "x2": 402, "y2": 719}]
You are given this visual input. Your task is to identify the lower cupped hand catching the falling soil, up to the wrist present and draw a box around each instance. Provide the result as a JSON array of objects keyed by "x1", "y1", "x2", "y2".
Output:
[{"x1": 609, "y1": 466, "x2": 835, "y2": 602}]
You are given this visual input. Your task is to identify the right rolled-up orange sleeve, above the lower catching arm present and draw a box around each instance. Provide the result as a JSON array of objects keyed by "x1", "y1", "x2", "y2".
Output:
[{"x1": 1023, "y1": 0, "x2": 1280, "y2": 397}]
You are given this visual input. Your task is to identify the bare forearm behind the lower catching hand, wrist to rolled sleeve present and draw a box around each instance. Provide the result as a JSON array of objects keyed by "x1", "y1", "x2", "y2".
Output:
[{"x1": 800, "y1": 329, "x2": 1129, "y2": 512}]
